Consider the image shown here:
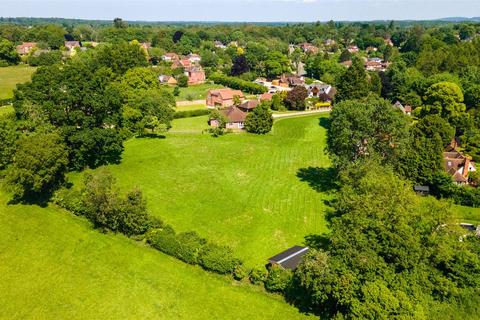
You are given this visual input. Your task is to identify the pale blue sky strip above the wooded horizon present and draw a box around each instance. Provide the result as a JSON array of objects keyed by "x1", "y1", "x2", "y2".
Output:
[{"x1": 0, "y1": 0, "x2": 480, "y2": 22}]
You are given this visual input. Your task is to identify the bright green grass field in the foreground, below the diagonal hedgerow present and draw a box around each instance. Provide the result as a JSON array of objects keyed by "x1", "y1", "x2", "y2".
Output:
[{"x1": 0, "y1": 194, "x2": 312, "y2": 320}]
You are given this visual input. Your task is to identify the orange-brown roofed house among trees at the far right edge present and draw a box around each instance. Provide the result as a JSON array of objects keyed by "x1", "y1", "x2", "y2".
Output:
[{"x1": 443, "y1": 149, "x2": 477, "y2": 185}]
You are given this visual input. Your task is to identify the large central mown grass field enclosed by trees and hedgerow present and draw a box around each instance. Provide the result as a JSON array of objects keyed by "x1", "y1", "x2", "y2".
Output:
[{"x1": 71, "y1": 115, "x2": 330, "y2": 266}]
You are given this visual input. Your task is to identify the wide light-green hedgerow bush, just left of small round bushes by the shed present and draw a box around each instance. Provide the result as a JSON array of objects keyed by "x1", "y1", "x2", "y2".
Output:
[{"x1": 198, "y1": 243, "x2": 241, "y2": 274}]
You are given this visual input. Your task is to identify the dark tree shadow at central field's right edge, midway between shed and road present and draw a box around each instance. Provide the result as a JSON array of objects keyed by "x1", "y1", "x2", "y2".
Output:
[{"x1": 297, "y1": 167, "x2": 339, "y2": 192}]
